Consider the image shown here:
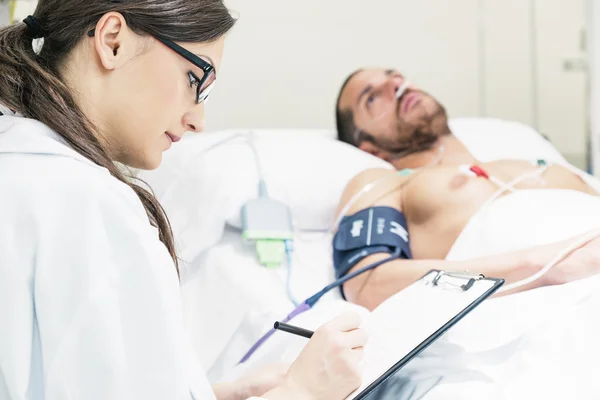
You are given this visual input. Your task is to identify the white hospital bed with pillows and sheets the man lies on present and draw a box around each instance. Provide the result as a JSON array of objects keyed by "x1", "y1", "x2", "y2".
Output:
[{"x1": 140, "y1": 119, "x2": 600, "y2": 399}]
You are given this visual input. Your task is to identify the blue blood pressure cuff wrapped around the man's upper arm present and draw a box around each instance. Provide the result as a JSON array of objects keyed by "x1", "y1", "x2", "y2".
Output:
[{"x1": 333, "y1": 207, "x2": 412, "y2": 279}]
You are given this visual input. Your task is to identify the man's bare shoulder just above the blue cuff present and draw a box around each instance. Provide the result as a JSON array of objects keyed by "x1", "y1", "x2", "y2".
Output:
[{"x1": 338, "y1": 168, "x2": 405, "y2": 214}]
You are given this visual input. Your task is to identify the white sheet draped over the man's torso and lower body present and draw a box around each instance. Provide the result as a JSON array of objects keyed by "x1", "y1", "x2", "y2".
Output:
[{"x1": 407, "y1": 188, "x2": 600, "y2": 399}]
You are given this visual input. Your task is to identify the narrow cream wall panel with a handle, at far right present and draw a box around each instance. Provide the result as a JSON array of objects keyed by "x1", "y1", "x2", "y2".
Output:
[{"x1": 534, "y1": 0, "x2": 584, "y2": 166}]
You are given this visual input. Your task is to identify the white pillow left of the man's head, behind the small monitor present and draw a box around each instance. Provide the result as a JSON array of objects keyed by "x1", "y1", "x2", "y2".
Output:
[{"x1": 139, "y1": 130, "x2": 393, "y2": 261}]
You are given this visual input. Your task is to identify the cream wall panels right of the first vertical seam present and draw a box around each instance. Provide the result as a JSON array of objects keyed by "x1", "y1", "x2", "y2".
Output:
[{"x1": 482, "y1": 0, "x2": 594, "y2": 168}]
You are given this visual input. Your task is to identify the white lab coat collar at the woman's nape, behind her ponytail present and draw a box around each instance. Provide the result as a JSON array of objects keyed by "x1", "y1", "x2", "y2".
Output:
[{"x1": 0, "y1": 114, "x2": 102, "y2": 168}]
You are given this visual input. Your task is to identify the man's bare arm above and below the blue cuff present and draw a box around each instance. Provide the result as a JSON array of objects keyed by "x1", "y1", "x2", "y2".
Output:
[{"x1": 340, "y1": 169, "x2": 600, "y2": 310}]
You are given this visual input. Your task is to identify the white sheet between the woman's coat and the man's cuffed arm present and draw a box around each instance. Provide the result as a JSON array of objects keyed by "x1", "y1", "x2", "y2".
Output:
[{"x1": 182, "y1": 227, "x2": 361, "y2": 380}]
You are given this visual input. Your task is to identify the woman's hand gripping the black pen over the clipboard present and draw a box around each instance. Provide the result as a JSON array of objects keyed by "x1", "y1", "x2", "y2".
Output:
[{"x1": 263, "y1": 313, "x2": 367, "y2": 400}]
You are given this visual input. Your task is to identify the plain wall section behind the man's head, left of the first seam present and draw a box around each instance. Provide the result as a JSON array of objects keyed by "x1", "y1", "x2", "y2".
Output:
[{"x1": 207, "y1": 0, "x2": 479, "y2": 129}]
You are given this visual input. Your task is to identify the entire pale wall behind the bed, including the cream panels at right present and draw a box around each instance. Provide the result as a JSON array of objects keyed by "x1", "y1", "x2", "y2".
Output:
[{"x1": 207, "y1": 0, "x2": 592, "y2": 167}]
